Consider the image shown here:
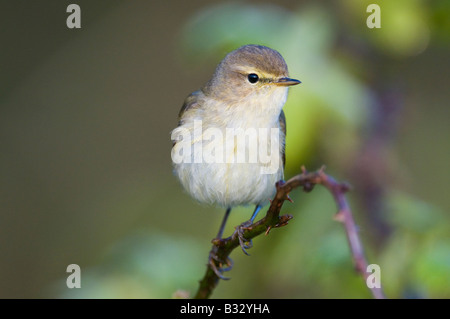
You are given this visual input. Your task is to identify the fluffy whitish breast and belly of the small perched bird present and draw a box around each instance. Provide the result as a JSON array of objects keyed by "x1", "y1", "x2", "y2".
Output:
[{"x1": 172, "y1": 89, "x2": 286, "y2": 207}]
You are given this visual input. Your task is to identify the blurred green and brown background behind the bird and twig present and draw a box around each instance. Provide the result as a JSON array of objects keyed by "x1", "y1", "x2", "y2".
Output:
[{"x1": 0, "y1": 0, "x2": 450, "y2": 298}]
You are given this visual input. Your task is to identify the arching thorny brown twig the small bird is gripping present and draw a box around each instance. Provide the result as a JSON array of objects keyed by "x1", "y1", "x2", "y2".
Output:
[{"x1": 194, "y1": 167, "x2": 384, "y2": 299}]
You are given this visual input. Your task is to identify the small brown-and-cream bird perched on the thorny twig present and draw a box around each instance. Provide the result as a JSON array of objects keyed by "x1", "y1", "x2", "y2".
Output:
[{"x1": 172, "y1": 45, "x2": 300, "y2": 273}]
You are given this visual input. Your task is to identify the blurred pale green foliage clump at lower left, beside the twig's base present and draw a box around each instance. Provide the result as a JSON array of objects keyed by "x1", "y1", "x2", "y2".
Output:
[{"x1": 57, "y1": 230, "x2": 204, "y2": 299}]
